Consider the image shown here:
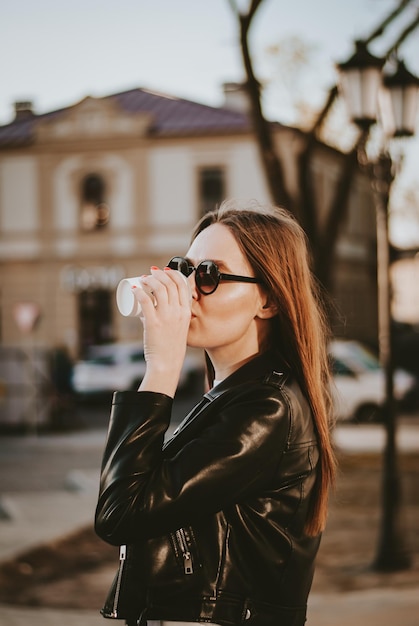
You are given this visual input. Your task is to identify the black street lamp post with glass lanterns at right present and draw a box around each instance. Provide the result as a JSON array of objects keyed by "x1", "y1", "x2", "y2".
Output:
[{"x1": 338, "y1": 41, "x2": 419, "y2": 571}]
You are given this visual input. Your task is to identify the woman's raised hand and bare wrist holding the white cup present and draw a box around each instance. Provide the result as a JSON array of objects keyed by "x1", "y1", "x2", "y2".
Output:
[{"x1": 134, "y1": 267, "x2": 191, "y2": 397}]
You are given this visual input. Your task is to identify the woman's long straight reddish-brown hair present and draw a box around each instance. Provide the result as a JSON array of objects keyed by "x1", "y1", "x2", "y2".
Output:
[{"x1": 192, "y1": 200, "x2": 336, "y2": 536}]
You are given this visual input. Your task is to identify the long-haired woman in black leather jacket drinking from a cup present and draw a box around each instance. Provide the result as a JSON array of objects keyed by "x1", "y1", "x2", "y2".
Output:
[{"x1": 96, "y1": 202, "x2": 334, "y2": 626}]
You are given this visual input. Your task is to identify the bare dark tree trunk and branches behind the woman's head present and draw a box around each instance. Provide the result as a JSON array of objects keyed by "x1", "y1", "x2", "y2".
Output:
[{"x1": 228, "y1": 0, "x2": 418, "y2": 289}]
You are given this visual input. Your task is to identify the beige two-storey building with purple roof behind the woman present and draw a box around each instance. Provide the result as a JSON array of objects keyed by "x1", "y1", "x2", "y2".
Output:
[{"x1": 0, "y1": 84, "x2": 376, "y2": 356}]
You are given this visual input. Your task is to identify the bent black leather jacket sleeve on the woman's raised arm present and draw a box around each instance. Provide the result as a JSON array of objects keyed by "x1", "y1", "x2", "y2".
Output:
[{"x1": 95, "y1": 386, "x2": 290, "y2": 545}]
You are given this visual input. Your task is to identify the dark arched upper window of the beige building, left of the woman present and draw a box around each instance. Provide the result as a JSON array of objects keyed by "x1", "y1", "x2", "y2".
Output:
[{"x1": 80, "y1": 174, "x2": 109, "y2": 231}]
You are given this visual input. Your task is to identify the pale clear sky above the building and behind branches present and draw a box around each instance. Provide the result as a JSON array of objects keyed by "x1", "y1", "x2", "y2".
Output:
[{"x1": 0, "y1": 0, "x2": 419, "y2": 237}]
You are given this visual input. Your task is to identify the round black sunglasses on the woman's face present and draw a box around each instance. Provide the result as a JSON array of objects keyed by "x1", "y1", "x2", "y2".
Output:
[{"x1": 167, "y1": 256, "x2": 261, "y2": 296}]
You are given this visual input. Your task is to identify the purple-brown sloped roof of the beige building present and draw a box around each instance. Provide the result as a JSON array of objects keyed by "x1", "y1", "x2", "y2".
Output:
[{"x1": 0, "y1": 88, "x2": 260, "y2": 147}]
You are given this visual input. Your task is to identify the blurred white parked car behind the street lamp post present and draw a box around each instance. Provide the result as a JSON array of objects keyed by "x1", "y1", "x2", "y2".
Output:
[{"x1": 329, "y1": 339, "x2": 414, "y2": 422}]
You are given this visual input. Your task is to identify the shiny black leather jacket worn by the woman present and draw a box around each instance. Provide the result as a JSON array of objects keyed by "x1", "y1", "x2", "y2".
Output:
[{"x1": 96, "y1": 353, "x2": 320, "y2": 626}]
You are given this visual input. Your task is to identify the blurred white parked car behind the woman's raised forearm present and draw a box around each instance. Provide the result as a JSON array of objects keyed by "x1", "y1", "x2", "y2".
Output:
[{"x1": 73, "y1": 343, "x2": 204, "y2": 395}]
